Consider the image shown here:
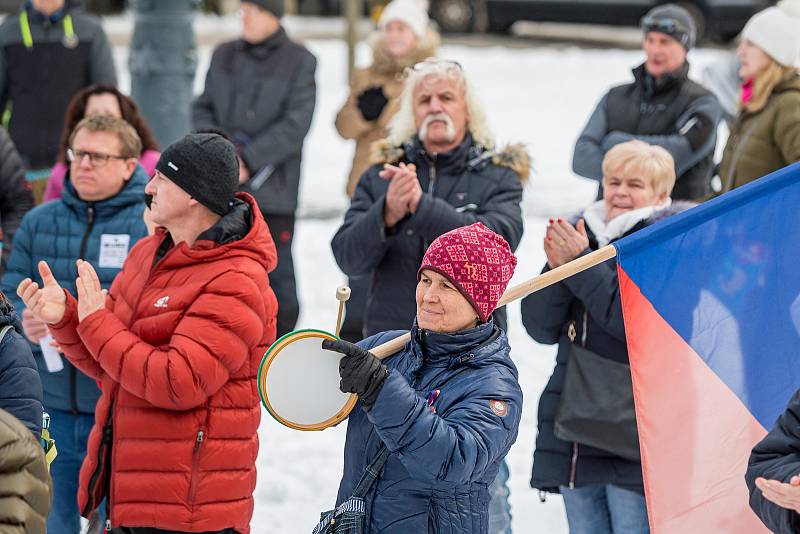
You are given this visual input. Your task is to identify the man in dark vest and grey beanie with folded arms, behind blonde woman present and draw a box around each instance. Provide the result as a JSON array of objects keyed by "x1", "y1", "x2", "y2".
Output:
[{"x1": 572, "y1": 4, "x2": 722, "y2": 200}]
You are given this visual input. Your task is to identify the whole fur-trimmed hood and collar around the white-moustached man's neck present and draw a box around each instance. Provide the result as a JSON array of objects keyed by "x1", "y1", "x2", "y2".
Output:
[{"x1": 370, "y1": 133, "x2": 531, "y2": 184}]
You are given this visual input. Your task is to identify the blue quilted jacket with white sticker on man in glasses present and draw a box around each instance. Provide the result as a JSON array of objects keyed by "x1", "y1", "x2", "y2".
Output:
[{"x1": 2, "y1": 166, "x2": 148, "y2": 414}]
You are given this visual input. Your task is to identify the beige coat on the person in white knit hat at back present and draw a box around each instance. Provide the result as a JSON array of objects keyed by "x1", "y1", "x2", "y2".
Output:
[{"x1": 336, "y1": 29, "x2": 439, "y2": 197}]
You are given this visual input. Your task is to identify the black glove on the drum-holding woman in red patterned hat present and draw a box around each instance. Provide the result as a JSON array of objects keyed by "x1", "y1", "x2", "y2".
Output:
[{"x1": 322, "y1": 339, "x2": 389, "y2": 408}]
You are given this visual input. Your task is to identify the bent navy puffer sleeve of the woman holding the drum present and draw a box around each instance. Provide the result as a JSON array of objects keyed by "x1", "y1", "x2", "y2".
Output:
[{"x1": 367, "y1": 360, "x2": 522, "y2": 484}]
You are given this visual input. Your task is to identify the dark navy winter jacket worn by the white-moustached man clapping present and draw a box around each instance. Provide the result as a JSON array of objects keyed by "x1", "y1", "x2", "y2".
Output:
[{"x1": 331, "y1": 134, "x2": 528, "y2": 336}]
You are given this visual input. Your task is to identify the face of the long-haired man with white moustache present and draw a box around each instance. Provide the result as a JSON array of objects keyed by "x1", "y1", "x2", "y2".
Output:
[{"x1": 413, "y1": 75, "x2": 469, "y2": 153}]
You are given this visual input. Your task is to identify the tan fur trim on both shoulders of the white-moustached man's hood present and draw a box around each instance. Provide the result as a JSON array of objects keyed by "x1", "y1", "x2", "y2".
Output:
[{"x1": 370, "y1": 138, "x2": 531, "y2": 185}]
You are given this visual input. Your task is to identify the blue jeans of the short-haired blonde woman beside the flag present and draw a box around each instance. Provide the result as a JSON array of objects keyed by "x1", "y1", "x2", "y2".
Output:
[{"x1": 561, "y1": 484, "x2": 650, "y2": 534}]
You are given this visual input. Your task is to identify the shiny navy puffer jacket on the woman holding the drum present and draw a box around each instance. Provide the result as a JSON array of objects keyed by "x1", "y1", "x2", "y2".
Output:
[{"x1": 336, "y1": 321, "x2": 522, "y2": 534}]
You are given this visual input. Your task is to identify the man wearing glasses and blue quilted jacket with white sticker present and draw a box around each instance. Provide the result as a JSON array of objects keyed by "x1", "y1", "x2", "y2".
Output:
[{"x1": 2, "y1": 115, "x2": 148, "y2": 534}]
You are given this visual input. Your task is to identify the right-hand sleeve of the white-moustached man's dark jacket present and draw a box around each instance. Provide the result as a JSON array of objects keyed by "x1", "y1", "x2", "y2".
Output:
[{"x1": 408, "y1": 167, "x2": 522, "y2": 250}]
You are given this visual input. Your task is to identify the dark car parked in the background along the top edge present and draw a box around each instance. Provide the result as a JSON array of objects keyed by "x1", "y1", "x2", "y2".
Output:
[{"x1": 430, "y1": 0, "x2": 775, "y2": 41}]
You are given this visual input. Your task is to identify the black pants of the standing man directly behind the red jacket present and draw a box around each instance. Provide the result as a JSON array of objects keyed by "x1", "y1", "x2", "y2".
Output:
[{"x1": 262, "y1": 212, "x2": 300, "y2": 337}]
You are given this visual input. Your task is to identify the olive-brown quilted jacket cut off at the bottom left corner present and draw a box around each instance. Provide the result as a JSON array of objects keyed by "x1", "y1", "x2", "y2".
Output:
[{"x1": 0, "y1": 410, "x2": 51, "y2": 534}]
